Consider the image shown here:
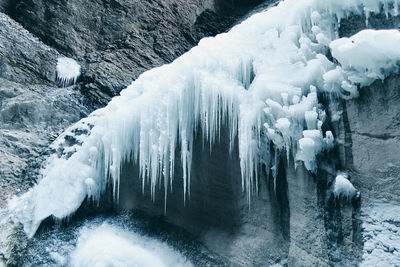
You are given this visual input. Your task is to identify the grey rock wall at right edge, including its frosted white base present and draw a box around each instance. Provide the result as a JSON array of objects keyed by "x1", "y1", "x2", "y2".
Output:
[{"x1": 332, "y1": 75, "x2": 400, "y2": 265}]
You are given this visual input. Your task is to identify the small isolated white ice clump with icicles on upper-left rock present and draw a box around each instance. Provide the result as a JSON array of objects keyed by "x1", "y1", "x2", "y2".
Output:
[{"x1": 56, "y1": 57, "x2": 81, "y2": 87}]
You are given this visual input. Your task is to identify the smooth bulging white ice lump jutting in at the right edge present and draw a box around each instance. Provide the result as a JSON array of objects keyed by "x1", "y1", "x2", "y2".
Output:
[{"x1": 324, "y1": 30, "x2": 400, "y2": 97}]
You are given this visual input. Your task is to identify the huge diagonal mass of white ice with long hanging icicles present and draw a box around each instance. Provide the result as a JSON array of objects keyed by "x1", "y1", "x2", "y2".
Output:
[{"x1": 9, "y1": 0, "x2": 400, "y2": 238}]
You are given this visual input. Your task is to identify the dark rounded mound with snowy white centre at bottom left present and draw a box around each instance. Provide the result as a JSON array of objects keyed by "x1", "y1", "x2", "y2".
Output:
[{"x1": 26, "y1": 213, "x2": 224, "y2": 267}]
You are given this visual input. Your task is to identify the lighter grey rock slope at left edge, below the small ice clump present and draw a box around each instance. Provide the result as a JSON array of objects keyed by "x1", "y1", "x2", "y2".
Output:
[{"x1": 0, "y1": 13, "x2": 85, "y2": 206}]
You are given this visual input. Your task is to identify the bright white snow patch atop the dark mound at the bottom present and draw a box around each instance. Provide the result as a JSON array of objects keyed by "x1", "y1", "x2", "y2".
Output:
[{"x1": 70, "y1": 223, "x2": 192, "y2": 267}]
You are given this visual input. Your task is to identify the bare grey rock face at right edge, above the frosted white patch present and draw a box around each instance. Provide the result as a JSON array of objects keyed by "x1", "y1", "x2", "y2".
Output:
[{"x1": 342, "y1": 75, "x2": 400, "y2": 202}]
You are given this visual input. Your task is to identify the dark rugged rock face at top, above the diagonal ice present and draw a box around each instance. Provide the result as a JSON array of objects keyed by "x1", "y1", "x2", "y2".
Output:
[{"x1": 4, "y1": 0, "x2": 271, "y2": 104}]
